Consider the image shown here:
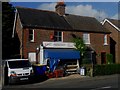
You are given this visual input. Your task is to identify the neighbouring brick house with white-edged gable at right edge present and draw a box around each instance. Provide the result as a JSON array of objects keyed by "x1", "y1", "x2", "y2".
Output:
[{"x1": 102, "y1": 19, "x2": 120, "y2": 63}]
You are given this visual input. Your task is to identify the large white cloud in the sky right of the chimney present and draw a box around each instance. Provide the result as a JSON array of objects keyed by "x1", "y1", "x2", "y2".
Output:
[{"x1": 66, "y1": 5, "x2": 108, "y2": 19}]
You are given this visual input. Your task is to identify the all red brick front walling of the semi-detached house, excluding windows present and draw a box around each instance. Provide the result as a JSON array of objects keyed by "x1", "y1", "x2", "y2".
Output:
[{"x1": 19, "y1": 29, "x2": 110, "y2": 64}]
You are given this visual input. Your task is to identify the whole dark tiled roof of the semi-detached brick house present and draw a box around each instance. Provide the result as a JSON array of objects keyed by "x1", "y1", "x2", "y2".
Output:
[{"x1": 16, "y1": 7, "x2": 110, "y2": 33}]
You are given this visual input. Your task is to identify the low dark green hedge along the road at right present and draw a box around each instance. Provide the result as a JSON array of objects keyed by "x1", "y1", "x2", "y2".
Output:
[{"x1": 94, "y1": 64, "x2": 120, "y2": 76}]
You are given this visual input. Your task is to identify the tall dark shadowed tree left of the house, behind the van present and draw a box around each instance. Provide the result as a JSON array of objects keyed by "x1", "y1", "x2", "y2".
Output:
[{"x1": 2, "y1": 2, "x2": 18, "y2": 59}]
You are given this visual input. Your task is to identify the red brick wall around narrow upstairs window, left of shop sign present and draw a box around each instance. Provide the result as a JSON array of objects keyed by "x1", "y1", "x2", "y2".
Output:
[{"x1": 23, "y1": 28, "x2": 53, "y2": 58}]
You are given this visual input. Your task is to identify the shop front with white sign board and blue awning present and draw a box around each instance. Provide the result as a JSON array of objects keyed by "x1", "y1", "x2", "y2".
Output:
[{"x1": 40, "y1": 42, "x2": 80, "y2": 72}]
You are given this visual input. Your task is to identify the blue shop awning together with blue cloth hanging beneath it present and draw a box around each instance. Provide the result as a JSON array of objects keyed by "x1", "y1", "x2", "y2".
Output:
[{"x1": 44, "y1": 49, "x2": 80, "y2": 72}]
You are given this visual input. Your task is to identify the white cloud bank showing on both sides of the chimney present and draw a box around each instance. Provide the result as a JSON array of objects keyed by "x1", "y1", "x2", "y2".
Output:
[{"x1": 37, "y1": 3, "x2": 108, "y2": 20}]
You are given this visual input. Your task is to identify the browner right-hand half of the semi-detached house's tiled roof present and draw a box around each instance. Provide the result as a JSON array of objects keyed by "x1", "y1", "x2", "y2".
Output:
[{"x1": 65, "y1": 14, "x2": 110, "y2": 33}]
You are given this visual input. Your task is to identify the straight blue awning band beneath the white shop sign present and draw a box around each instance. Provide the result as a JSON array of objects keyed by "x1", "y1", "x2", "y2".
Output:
[{"x1": 44, "y1": 49, "x2": 80, "y2": 59}]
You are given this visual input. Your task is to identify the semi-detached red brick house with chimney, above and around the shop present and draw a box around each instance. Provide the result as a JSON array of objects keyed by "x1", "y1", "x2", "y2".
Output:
[{"x1": 13, "y1": 2, "x2": 110, "y2": 64}]
